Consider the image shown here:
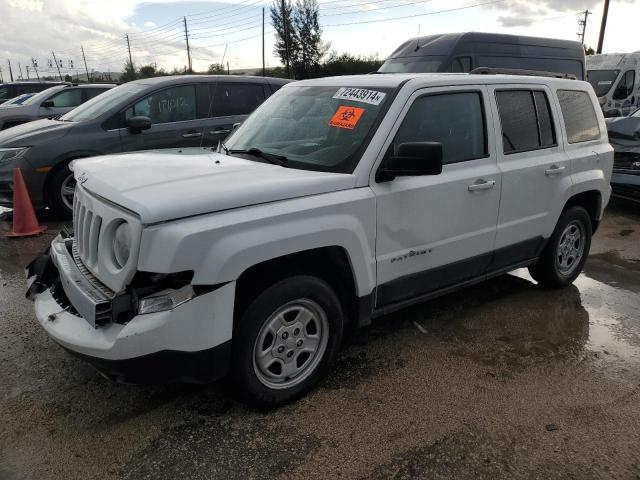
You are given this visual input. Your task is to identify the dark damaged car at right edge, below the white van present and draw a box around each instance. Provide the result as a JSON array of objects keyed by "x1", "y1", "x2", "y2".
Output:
[{"x1": 606, "y1": 109, "x2": 640, "y2": 202}]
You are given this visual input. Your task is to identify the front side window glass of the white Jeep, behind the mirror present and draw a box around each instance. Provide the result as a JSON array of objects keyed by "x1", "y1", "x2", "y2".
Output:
[{"x1": 393, "y1": 92, "x2": 487, "y2": 164}]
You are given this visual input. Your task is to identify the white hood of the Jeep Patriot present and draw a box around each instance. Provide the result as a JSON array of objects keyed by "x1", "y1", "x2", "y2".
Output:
[{"x1": 73, "y1": 148, "x2": 355, "y2": 224}]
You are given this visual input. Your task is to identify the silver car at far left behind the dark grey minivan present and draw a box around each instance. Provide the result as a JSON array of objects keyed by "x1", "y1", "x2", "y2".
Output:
[{"x1": 0, "y1": 83, "x2": 115, "y2": 130}]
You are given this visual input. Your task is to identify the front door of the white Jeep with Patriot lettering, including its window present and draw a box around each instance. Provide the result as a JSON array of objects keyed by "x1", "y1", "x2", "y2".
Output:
[{"x1": 372, "y1": 86, "x2": 501, "y2": 307}]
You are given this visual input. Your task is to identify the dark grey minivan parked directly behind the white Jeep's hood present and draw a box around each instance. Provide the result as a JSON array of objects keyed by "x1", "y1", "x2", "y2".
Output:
[{"x1": 0, "y1": 75, "x2": 289, "y2": 216}]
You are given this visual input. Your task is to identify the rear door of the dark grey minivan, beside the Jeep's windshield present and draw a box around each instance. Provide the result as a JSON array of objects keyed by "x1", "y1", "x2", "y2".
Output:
[{"x1": 204, "y1": 82, "x2": 266, "y2": 145}]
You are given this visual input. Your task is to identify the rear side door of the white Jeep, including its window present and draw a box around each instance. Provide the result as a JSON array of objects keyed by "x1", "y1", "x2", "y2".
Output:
[{"x1": 489, "y1": 85, "x2": 571, "y2": 270}]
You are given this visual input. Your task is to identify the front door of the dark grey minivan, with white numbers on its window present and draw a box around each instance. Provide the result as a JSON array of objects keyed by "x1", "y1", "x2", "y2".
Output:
[{"x1": 120, "y1": 83, "x2": 210, "y2": 152}]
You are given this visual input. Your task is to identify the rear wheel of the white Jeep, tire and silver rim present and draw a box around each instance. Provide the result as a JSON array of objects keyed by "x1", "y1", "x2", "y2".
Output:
[{"x1": 529, "y1": 206, "x2": 592, "y2": 288}]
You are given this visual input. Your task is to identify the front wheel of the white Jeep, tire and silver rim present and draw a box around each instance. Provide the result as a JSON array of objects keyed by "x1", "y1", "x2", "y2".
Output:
[{"x1": 229, "y1": 275, "x2": 344, "y2": 409}]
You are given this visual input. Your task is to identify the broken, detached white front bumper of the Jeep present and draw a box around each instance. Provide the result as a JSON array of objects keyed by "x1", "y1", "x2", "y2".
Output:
[{"x1": 26, "y1": 234, "x2": 235, "y2": 383}]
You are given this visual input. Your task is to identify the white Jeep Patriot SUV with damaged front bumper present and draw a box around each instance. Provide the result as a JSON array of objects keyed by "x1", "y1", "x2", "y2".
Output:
[{"x1": 27, "y1": 74, "x2": 613, "y2": 406}]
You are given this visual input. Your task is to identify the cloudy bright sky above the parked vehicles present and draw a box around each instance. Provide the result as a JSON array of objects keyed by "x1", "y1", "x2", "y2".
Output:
[{"x1": 0, "y1": 0, "x2": 640, "y2": 81}]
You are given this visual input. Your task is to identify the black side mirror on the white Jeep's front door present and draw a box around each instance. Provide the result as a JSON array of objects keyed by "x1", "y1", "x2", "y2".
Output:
[{"x1": 376, "y1": 142, "x2": 442, "y2": 182}]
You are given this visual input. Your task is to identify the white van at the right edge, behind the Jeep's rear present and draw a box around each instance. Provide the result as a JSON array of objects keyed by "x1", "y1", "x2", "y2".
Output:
[{"x1": 587, "y1": 52, "x2": 640, "y2": 117}]
